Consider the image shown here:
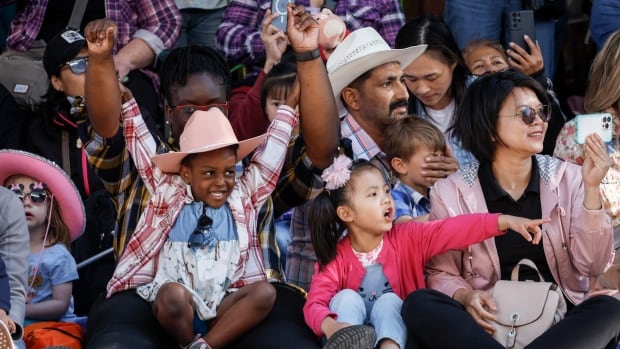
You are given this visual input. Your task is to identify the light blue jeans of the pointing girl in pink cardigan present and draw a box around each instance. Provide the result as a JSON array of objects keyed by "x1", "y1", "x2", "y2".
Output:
[{"x1": 329, "y1": 289, "x2": 407, "y2": 348}]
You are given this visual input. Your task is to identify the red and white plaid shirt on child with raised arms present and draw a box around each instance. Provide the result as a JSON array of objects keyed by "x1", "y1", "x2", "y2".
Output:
[{"x1": 108, "y1": 100, "x2": 297, "y2": 296}]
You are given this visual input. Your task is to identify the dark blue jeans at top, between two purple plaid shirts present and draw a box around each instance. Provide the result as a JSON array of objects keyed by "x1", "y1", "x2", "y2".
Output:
[{"x1": 174, "y1": 7, "x2": 226, "y2": 49}]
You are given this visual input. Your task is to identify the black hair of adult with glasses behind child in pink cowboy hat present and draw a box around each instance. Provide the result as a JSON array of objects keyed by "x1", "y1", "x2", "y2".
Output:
[{"x1": 159, "y1": 46, "x2": 231, "y2": 100}]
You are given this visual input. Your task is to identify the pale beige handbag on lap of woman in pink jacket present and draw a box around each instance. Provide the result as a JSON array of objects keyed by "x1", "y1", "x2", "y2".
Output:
[{"x1": 491, "y1": 259, "x2": 566, "y2": 349}]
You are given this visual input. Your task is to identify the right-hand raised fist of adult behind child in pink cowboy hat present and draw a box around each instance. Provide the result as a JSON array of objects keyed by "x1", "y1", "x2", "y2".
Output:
[{"x1": 286, "y1": 4, "x2": 320, "y2": 52}]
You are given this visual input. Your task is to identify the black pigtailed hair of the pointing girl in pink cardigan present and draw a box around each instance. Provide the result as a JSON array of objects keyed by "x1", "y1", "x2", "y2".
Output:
[{"x1": 308, "y1": 160, "x2": 380, "y2": 269}]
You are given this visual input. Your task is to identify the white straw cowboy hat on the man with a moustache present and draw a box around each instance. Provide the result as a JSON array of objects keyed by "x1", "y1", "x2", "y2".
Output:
[{"x1": 326, "y1": 27, "x2": 426, "y2": 116}]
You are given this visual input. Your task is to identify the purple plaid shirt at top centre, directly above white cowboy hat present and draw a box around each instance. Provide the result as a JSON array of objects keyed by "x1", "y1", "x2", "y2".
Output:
[{"x1": 216, "y1": 0, "x2": 405, "y2": 76}]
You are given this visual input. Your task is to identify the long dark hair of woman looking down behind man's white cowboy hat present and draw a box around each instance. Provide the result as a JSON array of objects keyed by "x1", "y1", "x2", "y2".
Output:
[{"x1": 395, "y1": 14, "x2": 471, "y2": 123}]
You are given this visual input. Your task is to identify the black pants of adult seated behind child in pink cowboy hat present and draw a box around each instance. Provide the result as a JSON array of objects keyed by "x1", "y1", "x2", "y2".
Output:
[{"x1": 86, "y1": 284, "x2": 321, "y2": 349}]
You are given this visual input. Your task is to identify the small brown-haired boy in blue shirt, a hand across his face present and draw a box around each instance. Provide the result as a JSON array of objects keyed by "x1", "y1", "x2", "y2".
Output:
[{"x1": 384, "y1": 116, "x2": 446, "y2": 223}]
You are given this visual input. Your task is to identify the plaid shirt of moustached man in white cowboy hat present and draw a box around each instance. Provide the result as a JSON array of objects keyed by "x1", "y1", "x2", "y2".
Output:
[{"x1": 286, "y1": 114, "x2": 391, "y2": 290}]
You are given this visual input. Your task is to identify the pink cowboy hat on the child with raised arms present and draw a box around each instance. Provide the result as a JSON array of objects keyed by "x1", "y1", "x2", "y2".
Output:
[{"x1": 152, "y1": 108, "x2": 267, "y2": 173}]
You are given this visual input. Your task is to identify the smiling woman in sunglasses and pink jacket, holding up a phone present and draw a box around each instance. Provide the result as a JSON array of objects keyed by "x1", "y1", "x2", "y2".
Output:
[{"x1": 402, "y1": 69, "x2": 620, "y2": 349}]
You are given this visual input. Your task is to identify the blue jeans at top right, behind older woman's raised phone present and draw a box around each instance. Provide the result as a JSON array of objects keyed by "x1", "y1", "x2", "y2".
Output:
[{"x1": 443, "y1": 0, "x2": 556, "y2": 80}]
